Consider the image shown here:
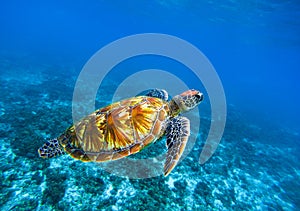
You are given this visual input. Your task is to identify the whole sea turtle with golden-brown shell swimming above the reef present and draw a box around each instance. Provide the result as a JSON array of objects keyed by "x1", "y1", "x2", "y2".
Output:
[{"x1": 38, "y1": 89, "x2": 203, "y2": 176}]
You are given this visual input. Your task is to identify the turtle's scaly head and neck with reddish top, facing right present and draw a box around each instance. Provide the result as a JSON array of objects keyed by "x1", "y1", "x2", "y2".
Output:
[{"x1": 170, "y1": 89, "x2": 203, "y2": 115}]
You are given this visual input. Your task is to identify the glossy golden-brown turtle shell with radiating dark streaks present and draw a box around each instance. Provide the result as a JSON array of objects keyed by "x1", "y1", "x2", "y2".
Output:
[{"x1": 59, "y1": 96, "x2": 170, "y2": 162}]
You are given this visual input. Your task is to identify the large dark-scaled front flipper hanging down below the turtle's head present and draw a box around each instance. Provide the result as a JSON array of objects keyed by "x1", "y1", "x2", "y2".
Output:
[{"x1": 164, "y1": 116, "x2": 190, "y2": 176}]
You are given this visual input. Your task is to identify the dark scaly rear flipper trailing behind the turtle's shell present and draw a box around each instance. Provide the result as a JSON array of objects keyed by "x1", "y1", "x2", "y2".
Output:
[{"x1": 38, "y1": 138, "x2": 64, "y2": 158}]
